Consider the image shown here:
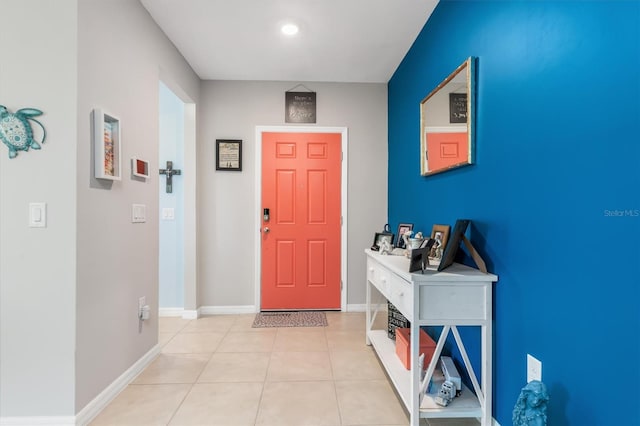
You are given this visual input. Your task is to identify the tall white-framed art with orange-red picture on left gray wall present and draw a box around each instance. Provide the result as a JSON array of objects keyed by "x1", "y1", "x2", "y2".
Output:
[{"x1": 93, "y1": 108, "x2": 122, "y2": 180}]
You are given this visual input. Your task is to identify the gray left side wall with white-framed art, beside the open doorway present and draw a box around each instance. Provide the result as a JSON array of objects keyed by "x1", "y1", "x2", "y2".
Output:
[{"x1": 76, "y1": 0, "x2": 200, "y2": 411}]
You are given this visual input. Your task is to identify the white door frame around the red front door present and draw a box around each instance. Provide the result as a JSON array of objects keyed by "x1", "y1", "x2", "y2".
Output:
[{"x1": 253, "y1": 126, "x2": 349, "y2": 312}]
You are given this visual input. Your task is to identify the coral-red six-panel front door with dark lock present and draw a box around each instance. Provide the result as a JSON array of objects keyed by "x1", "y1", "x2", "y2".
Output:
[{"x1": 261, "y1": 132, "x2": 342, "y2": 310}]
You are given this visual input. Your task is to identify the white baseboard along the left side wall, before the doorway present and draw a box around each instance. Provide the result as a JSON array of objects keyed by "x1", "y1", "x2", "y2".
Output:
[{"x1": 74, "y1": 345, "x2": 160, "y2": 426}]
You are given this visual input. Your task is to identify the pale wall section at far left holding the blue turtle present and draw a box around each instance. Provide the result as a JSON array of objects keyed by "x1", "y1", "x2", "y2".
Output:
[{"x1": 0, "y1": 0, "x2": 77, "y2": 417}]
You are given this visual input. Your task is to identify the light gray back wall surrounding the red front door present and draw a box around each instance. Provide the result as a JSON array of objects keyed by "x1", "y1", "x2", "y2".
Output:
[{"x1": 198, "y1": 81, "x2": 387, "y2": 307}]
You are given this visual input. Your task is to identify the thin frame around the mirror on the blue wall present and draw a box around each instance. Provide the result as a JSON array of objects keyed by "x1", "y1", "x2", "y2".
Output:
[{"x1": 420, "y1": 56, "x2": 476, "y2": 176}]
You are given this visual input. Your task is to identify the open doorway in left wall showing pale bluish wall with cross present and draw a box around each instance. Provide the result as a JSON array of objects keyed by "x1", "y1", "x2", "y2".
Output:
[{"x1": 155, "y1": 78, "x2": 198, "y2": 319}]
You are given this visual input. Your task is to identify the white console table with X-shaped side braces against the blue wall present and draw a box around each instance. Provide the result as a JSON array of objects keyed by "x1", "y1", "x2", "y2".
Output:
[{"x1": 365, "y1": 249, "x2": 498, "y2": 426}]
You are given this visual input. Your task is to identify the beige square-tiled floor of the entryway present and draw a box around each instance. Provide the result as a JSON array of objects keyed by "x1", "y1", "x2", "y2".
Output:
[{"x1": 91, "y1": 312, "x2": 478, "y2": 426}]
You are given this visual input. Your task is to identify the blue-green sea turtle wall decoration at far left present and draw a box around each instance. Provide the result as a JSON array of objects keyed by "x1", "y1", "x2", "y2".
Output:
[{"x1": 0, "y1": 105, "x2": 47, "y2": 158}]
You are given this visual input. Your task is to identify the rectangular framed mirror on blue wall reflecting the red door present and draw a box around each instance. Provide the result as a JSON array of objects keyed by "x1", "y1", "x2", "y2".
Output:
[{"x1": 420, "y1": 57, "x2": 475, "y2": 176}]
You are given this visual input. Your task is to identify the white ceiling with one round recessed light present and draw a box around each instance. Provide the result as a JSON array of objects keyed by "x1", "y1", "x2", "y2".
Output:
[{"x1": 140, "y1": 0, "x2": 438, "y2": 83}]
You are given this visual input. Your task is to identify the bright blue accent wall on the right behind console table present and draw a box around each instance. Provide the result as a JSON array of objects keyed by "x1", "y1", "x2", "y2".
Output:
[{"x1": 388, "y1": 1, "x2": 640, "y2": 426}]
